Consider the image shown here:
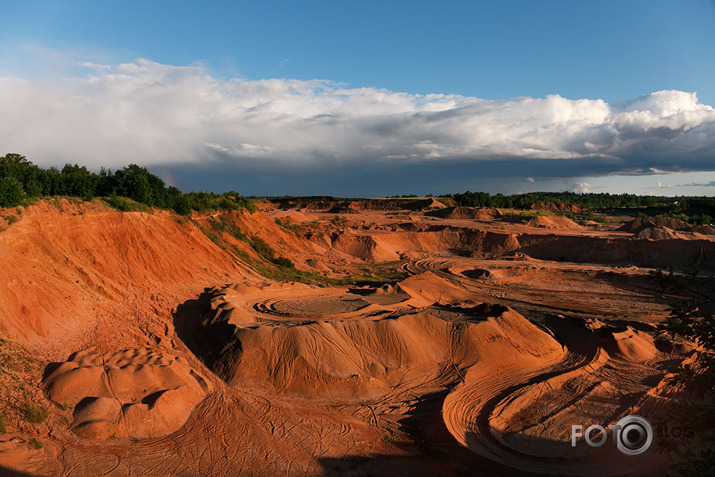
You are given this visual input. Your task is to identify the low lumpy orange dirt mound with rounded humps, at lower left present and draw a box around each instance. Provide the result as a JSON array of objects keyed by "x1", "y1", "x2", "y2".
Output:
[{"x1": 43, "y1": 349, "x2": 210, "y2": 439}]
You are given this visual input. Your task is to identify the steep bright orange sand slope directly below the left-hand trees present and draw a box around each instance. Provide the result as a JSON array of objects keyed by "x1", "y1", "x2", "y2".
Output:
[{"x1": 0, "y1": 199, "x2": 247, "y2": 352}]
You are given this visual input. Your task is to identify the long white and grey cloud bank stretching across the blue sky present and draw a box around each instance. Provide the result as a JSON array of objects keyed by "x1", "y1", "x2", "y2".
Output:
[{"x1": 0, "y1": 59, "x2": 715, "y2": 180}]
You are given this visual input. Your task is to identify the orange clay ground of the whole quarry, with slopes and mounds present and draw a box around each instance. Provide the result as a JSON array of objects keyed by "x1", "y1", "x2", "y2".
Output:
[{"x1": 0, "y1": 199, "x2": 715, "y2": 476}]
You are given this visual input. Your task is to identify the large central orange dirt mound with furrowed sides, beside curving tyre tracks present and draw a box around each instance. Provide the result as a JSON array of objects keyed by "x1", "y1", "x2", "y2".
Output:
[{"x1": 182, "y1": 273, "x2": 561, "y2": 401}]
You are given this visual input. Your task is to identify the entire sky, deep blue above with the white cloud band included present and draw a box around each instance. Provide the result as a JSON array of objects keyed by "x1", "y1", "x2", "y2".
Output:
[{"x1": 0, "y1": 0, "x2": 715, "y2": 195}]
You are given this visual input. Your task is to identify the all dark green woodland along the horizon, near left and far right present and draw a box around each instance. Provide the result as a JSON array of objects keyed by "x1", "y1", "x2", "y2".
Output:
[{"x1": 0, "y1": 154, "x2": 715, "y2": 223}]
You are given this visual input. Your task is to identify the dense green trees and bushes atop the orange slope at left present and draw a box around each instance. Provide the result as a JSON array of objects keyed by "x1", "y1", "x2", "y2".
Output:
[{"x1": 0, "y1": 154, "x2": 255, "y2": 215}]
